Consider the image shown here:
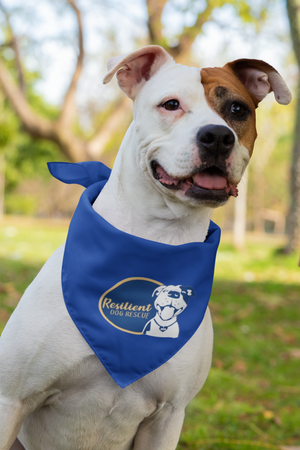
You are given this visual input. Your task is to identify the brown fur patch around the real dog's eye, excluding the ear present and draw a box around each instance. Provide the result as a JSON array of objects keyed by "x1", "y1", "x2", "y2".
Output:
[{"x1": 201, "y1": 66, "x2": 257, "y2": 156}]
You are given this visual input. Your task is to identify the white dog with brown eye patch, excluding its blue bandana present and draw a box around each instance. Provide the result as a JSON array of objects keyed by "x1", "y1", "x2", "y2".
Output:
[{"x1": 0, "y1": 46, "x2": 291, "y2": 450}]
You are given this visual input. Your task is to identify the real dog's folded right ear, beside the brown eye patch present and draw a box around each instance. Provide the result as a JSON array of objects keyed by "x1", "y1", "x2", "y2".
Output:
[{"x1": 224, "y1": 59, "x2": 292, "y2": 107}]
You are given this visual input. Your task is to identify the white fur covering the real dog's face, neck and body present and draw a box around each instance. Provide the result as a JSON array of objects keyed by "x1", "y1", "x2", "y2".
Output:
[{"x1": 0, "y1": 46, "x2": 288, "y2": 450}]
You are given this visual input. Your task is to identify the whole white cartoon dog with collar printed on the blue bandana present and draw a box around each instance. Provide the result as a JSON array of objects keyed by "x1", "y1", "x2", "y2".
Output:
[{"x1": 143, "y1": 285, "x2": 196, "y2": 338}]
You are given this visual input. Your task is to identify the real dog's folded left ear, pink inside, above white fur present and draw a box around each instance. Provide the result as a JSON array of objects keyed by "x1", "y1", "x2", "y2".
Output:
[{"x1": 103, "y1": 45, "x2": 175, "y2": 99}]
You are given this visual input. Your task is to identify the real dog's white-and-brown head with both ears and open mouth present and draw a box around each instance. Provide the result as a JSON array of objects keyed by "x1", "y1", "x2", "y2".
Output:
[{"x1": 104, "y1": 46, "x2": 291, "y2": 207}]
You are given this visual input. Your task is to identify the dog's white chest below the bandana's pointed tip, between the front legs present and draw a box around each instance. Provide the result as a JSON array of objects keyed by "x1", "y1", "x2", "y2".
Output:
[{"x1": 20, "y1": 356, "x2": 156, "y2": 450}]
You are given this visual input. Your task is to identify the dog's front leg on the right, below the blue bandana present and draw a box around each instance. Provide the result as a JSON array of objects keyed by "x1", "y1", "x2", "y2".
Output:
[{"x1": 133, "y1": 403, "x2": 185, "y2": 450}]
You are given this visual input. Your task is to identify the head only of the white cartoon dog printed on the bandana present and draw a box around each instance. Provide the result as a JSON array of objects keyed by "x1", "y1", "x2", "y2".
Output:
[{"x1": 153, "y1": 286, "x2": 195, "y2": 320}]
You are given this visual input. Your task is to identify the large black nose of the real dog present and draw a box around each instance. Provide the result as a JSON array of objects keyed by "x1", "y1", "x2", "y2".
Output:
[{"x1": 196, "y1": 125, "x2": 235, "y2": 156}]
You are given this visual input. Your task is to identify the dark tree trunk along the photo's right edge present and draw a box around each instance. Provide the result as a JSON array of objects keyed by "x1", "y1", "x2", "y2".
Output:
[{"x1": 285, "y1": 0, "x2": 300, "y2": 253}]
